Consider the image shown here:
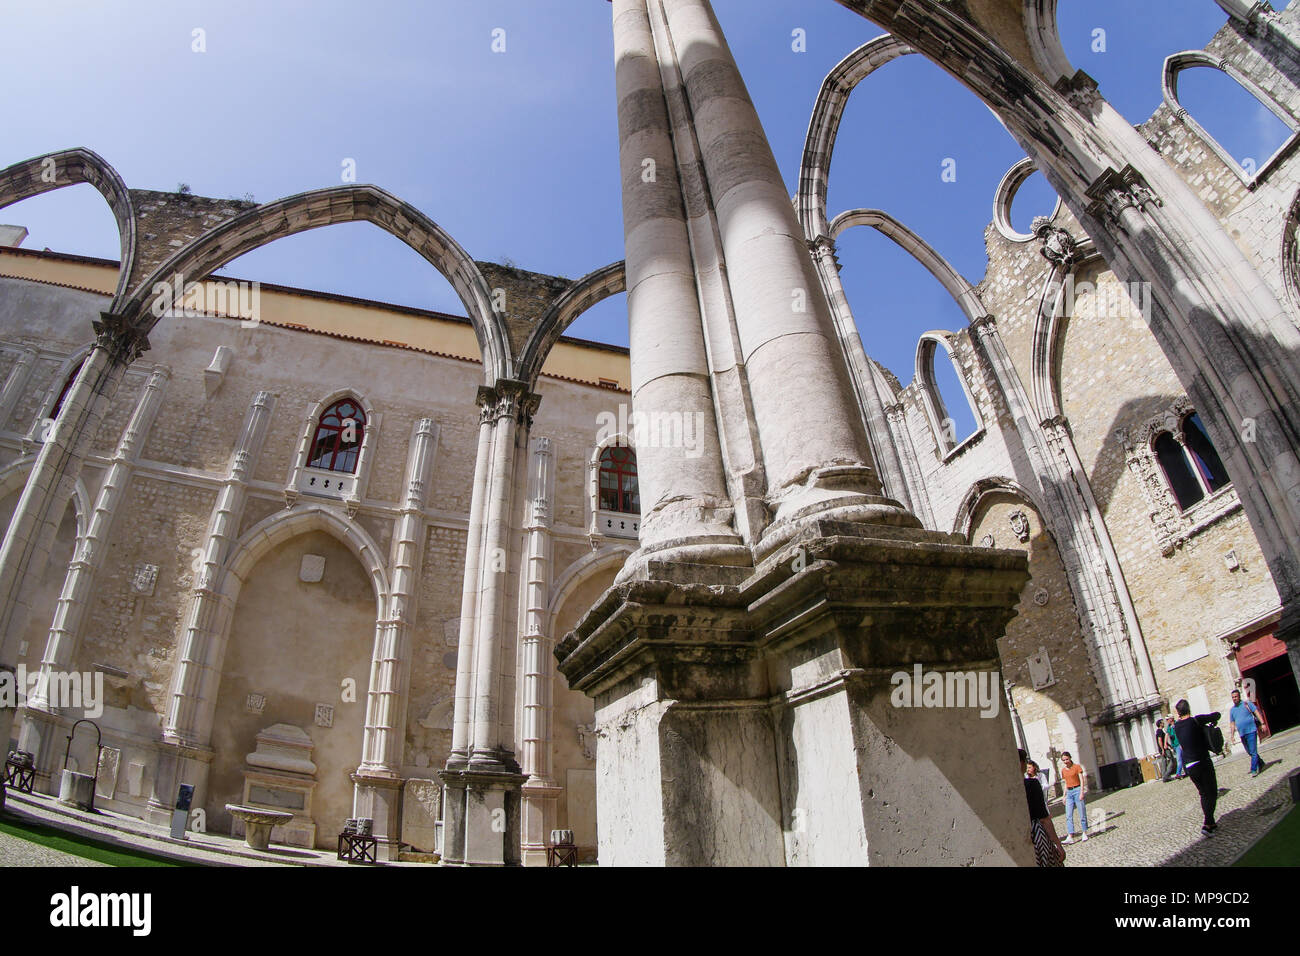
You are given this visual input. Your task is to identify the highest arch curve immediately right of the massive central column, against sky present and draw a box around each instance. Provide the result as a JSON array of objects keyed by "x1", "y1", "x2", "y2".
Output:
[{"x1": 794, "y1": 34, "x2": 917, "y2": 239}]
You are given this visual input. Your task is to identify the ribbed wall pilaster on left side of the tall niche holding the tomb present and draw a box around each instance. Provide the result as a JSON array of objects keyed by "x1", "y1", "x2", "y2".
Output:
[{"x1": 150, "y1": 392, "x2": 276, "y2": 818}]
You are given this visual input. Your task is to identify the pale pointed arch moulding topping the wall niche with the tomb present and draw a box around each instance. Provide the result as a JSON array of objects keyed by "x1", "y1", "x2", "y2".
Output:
[{"x1": 217, "y1": 505, "x2": 390, "y2": 616}]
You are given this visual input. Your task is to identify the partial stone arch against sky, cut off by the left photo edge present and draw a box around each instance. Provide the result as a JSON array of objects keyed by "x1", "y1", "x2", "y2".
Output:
[{"x1": 0, "y1": 147, "x2": 137, "y2": 312}]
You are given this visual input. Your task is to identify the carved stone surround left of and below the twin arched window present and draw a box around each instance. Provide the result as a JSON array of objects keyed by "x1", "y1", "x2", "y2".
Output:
[{"x1": 1115, "y1": 397, "x2": 1242, "y2": 557}]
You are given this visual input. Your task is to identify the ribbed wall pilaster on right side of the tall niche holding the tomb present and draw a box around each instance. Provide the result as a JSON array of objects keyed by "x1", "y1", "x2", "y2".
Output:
[{"x1": 352, "y1": 419, "x2": 437, "y2": 860}]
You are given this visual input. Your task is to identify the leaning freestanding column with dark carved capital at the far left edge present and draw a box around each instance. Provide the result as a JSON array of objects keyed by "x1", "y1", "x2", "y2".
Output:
[{"x1": 0, "y1": 312, "x2": 148, "y2": 780}]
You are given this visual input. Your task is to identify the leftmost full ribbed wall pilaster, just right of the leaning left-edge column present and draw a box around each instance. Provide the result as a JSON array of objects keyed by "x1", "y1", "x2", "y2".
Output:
[{"x1": 18, "y1": 365, "x2": 170, "y2": 782}]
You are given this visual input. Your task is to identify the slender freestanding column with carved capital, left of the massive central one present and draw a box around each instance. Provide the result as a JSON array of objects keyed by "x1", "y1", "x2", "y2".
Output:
[{"x1": 439, "y1": 378, "x2": 541, "y2": 865}]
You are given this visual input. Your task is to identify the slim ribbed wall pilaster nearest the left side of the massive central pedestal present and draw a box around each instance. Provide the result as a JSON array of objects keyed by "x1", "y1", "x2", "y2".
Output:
[{"x1": 520, "y1": 438, "x2": 562, "y2": 866}]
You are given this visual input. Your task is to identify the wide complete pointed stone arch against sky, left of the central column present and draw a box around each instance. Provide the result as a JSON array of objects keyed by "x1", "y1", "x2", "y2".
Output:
[{"x1": 120, "y1": 186, "x2": 512, "y2": 384}]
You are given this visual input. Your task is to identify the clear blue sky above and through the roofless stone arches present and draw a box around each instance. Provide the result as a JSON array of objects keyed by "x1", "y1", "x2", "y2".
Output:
[{"x1": 0, "y1": 0, "x2": 1282, "y2": 434}]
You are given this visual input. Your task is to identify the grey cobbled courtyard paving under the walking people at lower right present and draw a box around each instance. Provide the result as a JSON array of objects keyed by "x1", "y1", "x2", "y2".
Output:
[{"x1": 1052, "y1": 728, "x2": 1300, "y2": 866}]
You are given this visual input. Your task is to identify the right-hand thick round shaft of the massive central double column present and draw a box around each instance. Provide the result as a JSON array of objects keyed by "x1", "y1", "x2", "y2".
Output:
[{"x1": 650, "y1": 0, "x2": 915, "y2": 533}]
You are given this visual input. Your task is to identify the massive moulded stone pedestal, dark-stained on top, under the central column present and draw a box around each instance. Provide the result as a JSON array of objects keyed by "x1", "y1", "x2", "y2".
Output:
[{"x1": 556, "y1": 522, "x2": 1034, "y2": 866}]
